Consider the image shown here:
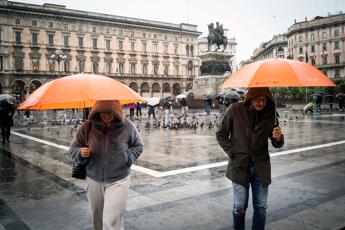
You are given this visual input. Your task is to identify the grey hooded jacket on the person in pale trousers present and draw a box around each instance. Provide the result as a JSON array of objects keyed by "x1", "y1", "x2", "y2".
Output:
[{"x1": 69, "y1": 101, "x2": 143, "y2": 182}]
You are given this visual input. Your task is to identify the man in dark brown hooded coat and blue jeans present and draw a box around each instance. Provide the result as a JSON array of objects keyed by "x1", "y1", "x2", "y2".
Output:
[{"x1": 216, "y1": 88, "x2": 284, "y2": 230}]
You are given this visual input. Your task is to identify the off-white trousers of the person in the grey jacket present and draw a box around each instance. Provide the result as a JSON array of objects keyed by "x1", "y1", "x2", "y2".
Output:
[{"x1": 86, "y1": 176, "x2": 130, "y2": 230}]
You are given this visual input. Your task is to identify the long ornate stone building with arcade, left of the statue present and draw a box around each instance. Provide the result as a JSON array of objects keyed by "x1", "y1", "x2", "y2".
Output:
[{"x1": 0, "y1": 0, "x2": 201, "y2": 101}]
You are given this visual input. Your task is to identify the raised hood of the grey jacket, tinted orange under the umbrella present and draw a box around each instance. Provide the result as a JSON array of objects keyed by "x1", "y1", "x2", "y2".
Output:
[{"x1": 89, "y1": 100, "x2": 124, "y2": 125}]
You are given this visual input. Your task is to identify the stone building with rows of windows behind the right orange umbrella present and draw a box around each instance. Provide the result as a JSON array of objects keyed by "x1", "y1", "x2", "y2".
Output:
[{"x1": 286, "y1": 14, "x2": 345, "y2": 79}]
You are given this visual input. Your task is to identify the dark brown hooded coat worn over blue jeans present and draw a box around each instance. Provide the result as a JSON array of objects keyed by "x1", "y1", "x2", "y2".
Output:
[{"x1": 216, "y1": 88, "x2": 284, "y2": 187}]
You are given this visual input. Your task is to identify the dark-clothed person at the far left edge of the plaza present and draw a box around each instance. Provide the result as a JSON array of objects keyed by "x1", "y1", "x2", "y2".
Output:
[{"x1": 0, "y1": 100, "x2": 15, "y2": 144}]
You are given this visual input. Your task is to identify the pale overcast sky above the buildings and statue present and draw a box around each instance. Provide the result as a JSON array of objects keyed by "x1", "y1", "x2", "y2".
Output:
[{"x1": 19, "y1": 0, "x2": 345, "y2": 63}]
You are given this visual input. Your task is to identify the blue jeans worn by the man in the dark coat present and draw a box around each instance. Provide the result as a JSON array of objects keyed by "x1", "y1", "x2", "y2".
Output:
[{"x1": 232, "y1": 166, "x2": 268, "y2": 230}]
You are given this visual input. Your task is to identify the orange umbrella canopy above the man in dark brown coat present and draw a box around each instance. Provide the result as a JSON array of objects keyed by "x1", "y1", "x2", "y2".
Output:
[{"x1": 221, "y1": 58, "x2": 335, "y2": 88}]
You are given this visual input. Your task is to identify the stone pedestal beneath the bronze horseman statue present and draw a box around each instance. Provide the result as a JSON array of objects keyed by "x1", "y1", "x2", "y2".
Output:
[{"x1": 193, "y1": 52, "x2": 233, "y2": 99}]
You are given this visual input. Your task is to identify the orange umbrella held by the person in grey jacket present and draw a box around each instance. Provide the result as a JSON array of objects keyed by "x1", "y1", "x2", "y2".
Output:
[{"x1": 19, "y1": 74, "x2": 144, "y2": 110}]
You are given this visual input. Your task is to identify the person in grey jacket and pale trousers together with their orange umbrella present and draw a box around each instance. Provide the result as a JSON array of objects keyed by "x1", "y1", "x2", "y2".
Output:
[{"x1": 19, "y1": 74, "x2": 143, "y2": 230}]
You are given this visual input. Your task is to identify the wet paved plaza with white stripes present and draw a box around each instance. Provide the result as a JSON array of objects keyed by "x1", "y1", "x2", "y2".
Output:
[{"x1": 0, "y1": 108, "x2": 345, "y2": 230}]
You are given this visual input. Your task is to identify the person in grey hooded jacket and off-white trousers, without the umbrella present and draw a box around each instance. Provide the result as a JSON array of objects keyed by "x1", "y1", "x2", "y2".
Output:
[{"x1": 69, "y1": 101, "x2": 143, "y2": 230}]
